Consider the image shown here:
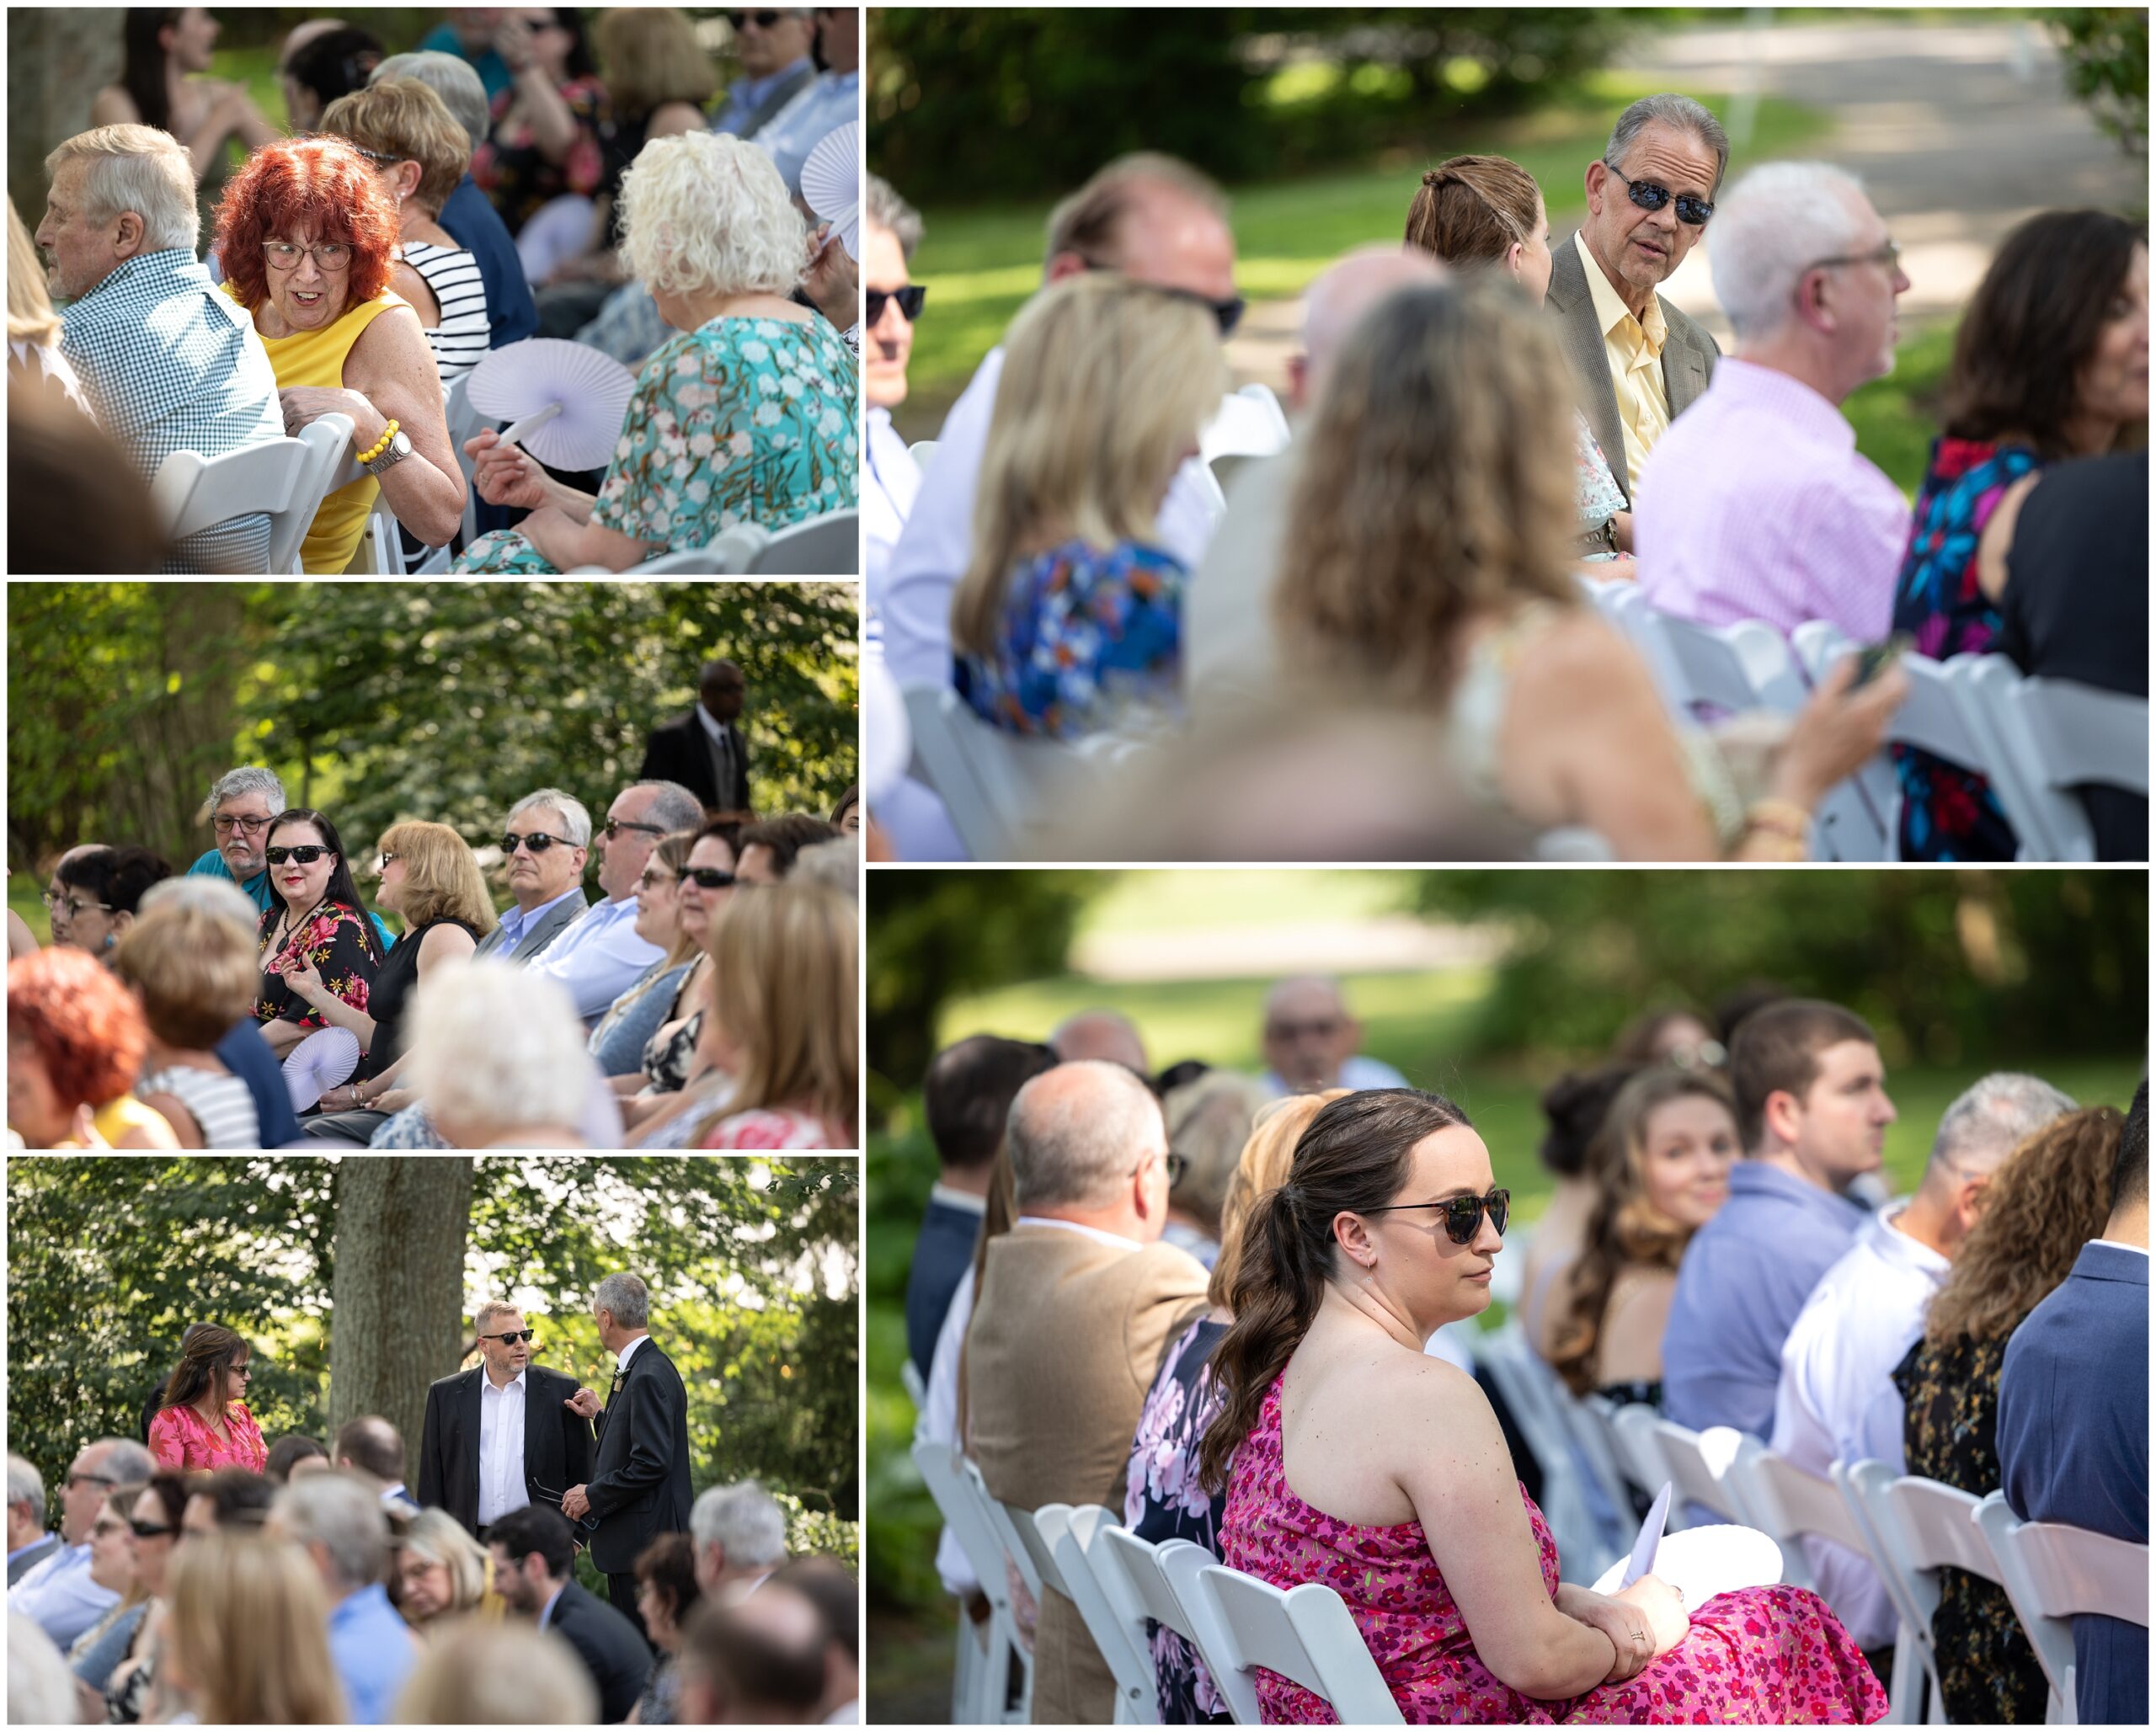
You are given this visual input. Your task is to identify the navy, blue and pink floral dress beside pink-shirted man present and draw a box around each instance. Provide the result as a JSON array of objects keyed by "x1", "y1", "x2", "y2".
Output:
[{"x1": 1893, "y1": 440, "x2": 2041, "y2": 860}]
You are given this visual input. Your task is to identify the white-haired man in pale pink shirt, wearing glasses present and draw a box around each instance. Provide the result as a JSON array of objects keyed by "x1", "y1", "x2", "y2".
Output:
[{"x1": 1632, "y1": 162, "x2": 1910, "y2": 642}]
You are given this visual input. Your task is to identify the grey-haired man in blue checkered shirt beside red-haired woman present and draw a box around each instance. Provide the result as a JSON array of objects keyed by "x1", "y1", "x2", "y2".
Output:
[{"x1": 34, "y1": 125, "x2": 285, "y2": 573}]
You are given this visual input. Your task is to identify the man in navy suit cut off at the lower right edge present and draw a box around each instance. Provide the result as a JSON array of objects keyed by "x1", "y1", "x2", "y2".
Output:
[{"x1": 1999, "y1": 1079, "x2": 2149, "y2": 1725}]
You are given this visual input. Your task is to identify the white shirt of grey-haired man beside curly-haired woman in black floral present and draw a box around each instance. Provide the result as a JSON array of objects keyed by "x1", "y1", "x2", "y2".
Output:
[{"x1": 1768, "y1": 1202, "x2": 1951, "y2": 1648}]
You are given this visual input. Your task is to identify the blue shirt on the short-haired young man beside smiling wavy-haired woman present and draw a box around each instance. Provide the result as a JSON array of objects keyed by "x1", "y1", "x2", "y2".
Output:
[{"x1": 1662, "y1": 1161, "x2": 1867, "y2": 1442}]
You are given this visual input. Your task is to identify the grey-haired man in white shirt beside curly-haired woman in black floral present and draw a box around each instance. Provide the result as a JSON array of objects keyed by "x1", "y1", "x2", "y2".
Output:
[{"x1": 1770, "y1": 1071, "x2": 2074, "y2": 1650}]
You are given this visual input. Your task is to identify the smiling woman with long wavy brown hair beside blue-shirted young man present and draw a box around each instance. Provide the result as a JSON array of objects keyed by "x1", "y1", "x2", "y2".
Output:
[{"x1": 1544, "y1": 1066, "x2": 1742, "y2": 1407}]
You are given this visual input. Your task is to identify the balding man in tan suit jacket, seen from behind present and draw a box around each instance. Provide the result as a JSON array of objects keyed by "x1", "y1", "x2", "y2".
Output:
[{"x1": 966, "y1": 1060, "x2": 1205, "y2": 1725}]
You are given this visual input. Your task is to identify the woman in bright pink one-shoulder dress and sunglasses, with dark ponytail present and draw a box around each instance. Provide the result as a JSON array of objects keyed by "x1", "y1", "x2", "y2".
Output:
[{"x1": 1198, "y1": 1088, "x2": 1886, "y2": 1725}]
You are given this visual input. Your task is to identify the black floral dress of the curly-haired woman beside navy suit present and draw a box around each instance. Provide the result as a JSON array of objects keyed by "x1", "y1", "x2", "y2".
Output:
[{"x1": 1893, "y1": 1330, "x2": 2048, "y2": 1725}]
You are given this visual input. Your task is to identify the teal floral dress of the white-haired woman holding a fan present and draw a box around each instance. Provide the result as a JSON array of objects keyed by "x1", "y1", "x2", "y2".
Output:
[{"x1": 455, "y1": 319, "x2": 860, "y2": 575}]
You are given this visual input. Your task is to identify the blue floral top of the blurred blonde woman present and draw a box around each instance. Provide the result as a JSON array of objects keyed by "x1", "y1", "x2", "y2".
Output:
[{"x1": 955, "y1": 541, "x2": 1190, "y2": 739}]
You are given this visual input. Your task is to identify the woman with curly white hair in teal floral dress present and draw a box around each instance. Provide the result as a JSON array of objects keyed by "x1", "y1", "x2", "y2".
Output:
[{"x1": 455, "y1": 131, "x2": 860, "y2": 575}]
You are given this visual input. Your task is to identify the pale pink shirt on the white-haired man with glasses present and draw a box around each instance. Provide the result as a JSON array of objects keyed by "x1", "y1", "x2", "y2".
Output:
[{"x1": 1632, "y1": 355, "x2": 1910, "y2": 642}]
